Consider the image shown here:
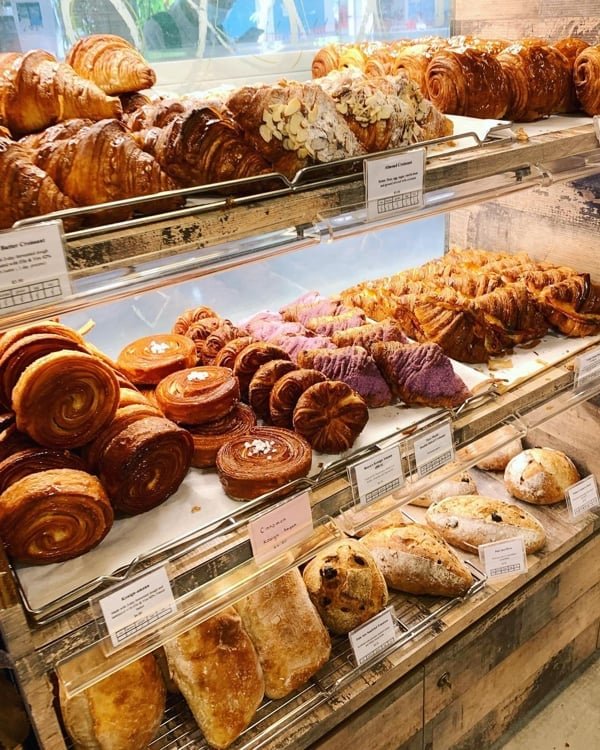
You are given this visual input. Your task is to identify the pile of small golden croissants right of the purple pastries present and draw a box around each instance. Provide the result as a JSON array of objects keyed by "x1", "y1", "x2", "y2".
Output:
[{"x1": 340, "y1": 249, "x2": 600, "y2": 363}]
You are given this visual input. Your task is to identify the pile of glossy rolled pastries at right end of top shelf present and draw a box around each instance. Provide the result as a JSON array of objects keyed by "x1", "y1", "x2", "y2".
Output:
[{"x1": 312, "y1": 36, "x2": 600, "y2": 122}]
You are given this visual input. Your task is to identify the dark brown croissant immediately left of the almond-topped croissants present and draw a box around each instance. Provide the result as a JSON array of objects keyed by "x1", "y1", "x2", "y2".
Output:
[{"x1": 134, "y1": 107, "x2": 271, "y2": 187}]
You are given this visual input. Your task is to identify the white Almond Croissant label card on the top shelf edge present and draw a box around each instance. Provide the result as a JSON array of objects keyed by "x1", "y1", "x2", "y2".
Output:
[{"x1": 364, "y1": 148, "x2": 426, "y2": 221}]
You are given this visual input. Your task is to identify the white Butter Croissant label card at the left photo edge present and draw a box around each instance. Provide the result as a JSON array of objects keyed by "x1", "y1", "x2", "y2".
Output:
[{"x1": 0, "y1": 221, "x2": 71, "y2": 314}]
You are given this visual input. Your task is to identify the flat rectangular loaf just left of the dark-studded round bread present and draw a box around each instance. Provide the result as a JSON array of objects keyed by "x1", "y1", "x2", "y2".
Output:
[{"x1": 235, "y1": 568, "x2": 331, "y2": 699}]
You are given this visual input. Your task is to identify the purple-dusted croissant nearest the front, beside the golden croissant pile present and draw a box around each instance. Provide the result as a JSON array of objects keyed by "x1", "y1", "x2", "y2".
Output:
[{"x1": 371, "y1": 341, "x2": 471, "y2": 409}]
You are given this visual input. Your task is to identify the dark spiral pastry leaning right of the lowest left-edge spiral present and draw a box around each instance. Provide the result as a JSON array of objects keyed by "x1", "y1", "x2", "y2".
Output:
[{"x1": 98, "y1": 417, "x2": 194, "y2": 515}]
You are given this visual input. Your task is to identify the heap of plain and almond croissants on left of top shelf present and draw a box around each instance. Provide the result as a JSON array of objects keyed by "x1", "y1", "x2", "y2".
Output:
[{"x1": 0, "y1": 35, "x2": 452, "y2": 228}]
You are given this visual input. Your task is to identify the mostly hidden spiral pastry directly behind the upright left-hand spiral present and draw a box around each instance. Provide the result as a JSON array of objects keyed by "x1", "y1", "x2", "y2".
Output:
[{"x1": 0, "y1": 333, "x2": 86, "y2": 406}]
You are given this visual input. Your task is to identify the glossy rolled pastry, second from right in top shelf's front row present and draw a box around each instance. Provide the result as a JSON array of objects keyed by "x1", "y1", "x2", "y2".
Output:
[{"x1": 496, "y1": 44, "x2": 571, "y2": 122}]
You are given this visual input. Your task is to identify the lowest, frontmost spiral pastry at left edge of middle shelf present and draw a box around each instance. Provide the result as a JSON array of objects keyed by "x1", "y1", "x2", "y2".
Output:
[{"x1": 0, "y1": 469, "x2": 113, "y2": 564}]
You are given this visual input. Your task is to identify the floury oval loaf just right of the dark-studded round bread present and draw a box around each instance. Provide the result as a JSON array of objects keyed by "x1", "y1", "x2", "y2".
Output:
[{"x1": 362, "y1": 523, "x2": 473, "y2": 596}]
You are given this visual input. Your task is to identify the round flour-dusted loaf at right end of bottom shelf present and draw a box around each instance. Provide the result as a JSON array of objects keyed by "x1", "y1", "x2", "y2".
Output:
[{"x1": 504, "y1": 448, "x2": 581, "y2": 505}]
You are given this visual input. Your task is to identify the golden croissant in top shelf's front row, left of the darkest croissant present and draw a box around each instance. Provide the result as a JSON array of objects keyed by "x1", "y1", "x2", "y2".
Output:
[{"x1": 36, "y1": 120, "x2": 176, "y2": 215}]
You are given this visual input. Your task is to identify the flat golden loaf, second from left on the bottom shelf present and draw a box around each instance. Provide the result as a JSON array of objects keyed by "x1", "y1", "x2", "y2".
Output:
[{"x1": 164, "y1": 607, "x2": 264, "y2": 748}]
